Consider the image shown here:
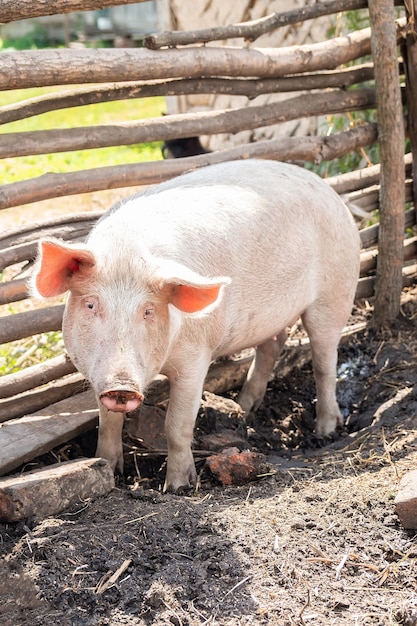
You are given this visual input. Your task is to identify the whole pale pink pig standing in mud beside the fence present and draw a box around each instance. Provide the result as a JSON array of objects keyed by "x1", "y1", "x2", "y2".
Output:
[{"x1": 32, "y1": 159, "x2": 359, "y2": 491}]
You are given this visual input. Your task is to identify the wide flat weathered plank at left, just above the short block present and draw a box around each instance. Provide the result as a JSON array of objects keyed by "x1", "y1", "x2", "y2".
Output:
[{"x1": 0, "y1": 391, "x2": 98, "y2": 475}]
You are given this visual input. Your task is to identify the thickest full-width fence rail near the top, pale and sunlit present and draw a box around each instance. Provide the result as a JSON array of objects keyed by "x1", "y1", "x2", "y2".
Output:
[{"x1": 0, "y1": 26, "x2": 380, "y2": 90}]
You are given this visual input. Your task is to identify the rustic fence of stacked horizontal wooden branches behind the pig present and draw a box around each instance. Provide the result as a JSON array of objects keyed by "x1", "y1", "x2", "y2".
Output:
[{"x1": 0, "y1": 0, "x2": 417, "y2": 471}]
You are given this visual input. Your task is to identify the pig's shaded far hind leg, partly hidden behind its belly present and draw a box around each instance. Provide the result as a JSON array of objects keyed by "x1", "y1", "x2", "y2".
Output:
[{"x1": 237, "y1": 330, "x2": 287, "y2": 413}]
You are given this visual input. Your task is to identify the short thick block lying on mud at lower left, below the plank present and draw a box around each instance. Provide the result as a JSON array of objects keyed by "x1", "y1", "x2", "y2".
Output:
[{"x1": 0, "y1": 458, "x2": 114, "y2": 522}]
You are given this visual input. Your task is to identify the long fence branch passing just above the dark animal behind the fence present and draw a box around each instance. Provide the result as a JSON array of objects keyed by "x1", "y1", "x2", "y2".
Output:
[{"x1": 0, "y1": 89, "x2": 375, "y2": 158}]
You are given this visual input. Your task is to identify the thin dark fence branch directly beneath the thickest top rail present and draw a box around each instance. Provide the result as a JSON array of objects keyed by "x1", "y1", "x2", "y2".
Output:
[{"x1": 0, "y1": 63, "x2": 374, "y2": 124}]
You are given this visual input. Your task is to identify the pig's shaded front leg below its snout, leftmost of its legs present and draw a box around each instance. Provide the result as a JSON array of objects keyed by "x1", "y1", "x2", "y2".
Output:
[{"x1": 96, "y1": 403, "x2": 125, "y2": 472}]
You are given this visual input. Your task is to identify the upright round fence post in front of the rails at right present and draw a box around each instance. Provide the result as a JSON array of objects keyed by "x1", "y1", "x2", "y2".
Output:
[{"x1": 368, "y1": 0, "x2": 405, "y2": 331}]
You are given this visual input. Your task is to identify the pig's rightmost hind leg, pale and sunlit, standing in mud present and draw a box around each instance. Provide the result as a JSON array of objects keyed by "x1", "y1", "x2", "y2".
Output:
[{"x1": 302, "y1": 303, "x2": 347, "y2": 437}]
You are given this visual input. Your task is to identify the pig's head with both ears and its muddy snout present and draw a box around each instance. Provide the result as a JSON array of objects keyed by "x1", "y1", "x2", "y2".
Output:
[{"x1": 31, "y1": 240, "x2": 230, "y2": 412}]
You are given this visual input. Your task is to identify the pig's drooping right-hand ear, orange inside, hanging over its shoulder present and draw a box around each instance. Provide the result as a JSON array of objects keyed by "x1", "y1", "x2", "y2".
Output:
[{"x1": 154, "y1": 262, "x2": 231, "y2": 314}]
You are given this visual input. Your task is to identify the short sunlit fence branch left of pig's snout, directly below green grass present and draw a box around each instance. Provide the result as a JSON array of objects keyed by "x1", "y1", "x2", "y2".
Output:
[{"x1": 0, "y1": 354, "x2": 76, "y2": 398}]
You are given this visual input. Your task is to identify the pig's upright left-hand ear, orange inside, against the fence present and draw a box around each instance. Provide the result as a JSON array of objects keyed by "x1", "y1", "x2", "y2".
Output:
[{"x1": 31, "y1": 240, "x2": 95, "y2": 298}]
